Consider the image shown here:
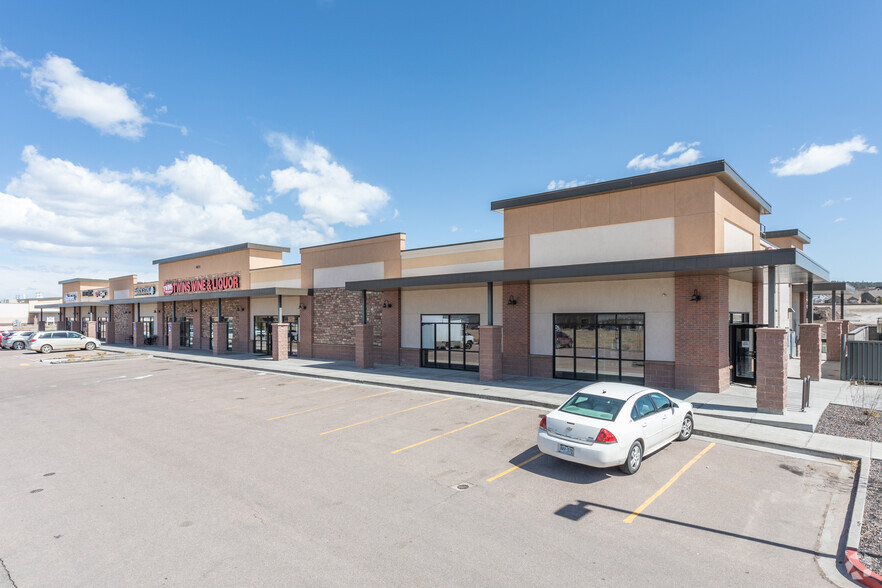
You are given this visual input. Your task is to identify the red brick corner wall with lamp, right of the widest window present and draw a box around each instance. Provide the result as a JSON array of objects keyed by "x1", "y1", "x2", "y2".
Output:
[{"x1": 674, "y1": 275, "x2": 729, "y2": 392}]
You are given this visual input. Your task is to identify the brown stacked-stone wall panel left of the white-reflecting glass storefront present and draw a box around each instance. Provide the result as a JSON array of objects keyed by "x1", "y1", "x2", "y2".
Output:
[{"x1": 312, "y1": 288, "x2": 382, "y2": 346}]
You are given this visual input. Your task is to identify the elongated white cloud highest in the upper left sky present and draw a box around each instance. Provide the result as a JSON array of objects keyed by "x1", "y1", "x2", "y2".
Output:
[{"x1": 30, "y1": 54, "x2": 149, "y2": 139}]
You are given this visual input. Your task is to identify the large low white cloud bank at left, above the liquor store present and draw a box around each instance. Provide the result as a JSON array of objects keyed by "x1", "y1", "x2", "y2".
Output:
[{"x1": 0, "y1": 146, "x2": 334, "y2": 260}]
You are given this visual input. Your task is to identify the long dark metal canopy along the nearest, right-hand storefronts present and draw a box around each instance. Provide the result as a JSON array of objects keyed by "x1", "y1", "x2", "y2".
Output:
[{"x1": 346, "y1": 249, "x2": 830, "y2": 291}]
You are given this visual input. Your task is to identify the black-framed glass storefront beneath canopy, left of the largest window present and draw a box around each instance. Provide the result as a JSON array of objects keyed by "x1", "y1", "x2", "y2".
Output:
[{"x1": 420, "y1": 314, "x2": 481, "y2": 372}]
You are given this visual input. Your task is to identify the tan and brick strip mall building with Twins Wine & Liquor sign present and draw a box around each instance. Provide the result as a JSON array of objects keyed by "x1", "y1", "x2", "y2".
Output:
[{"x1": 41, "y1": 161, "x2": 829, "y2": 391}]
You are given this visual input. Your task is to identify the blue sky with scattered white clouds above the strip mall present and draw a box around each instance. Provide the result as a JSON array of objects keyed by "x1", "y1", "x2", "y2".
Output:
[{"x1": 0, "y1": 0, "x2": 882, "y2": 298}]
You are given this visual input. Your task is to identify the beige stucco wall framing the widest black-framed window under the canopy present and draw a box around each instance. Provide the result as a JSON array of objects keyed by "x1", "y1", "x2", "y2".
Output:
[{"x1": 530, "y1": 278, "x2": 674, "y2": 361}]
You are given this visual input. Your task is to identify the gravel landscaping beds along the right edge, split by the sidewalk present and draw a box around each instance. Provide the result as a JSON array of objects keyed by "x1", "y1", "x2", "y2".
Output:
[{"x1": 816, "y1": 404, "x2": 882, "y2": 574}]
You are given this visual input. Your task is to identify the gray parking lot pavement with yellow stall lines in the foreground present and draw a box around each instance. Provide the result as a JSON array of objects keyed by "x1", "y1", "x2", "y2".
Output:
[{"x1": 0, "y1": 351, "x2": 853, "y2": 588}]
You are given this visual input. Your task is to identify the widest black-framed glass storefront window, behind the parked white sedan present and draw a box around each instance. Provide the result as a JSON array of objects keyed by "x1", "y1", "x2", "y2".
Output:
[{"x1": 551, "y1": 312, "x2": 646, "y2": 384}]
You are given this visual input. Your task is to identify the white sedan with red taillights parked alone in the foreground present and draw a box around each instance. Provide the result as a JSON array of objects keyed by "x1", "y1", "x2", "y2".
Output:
[{"x1": 537, "y1": 382, "x2": 693, "y2": 474}]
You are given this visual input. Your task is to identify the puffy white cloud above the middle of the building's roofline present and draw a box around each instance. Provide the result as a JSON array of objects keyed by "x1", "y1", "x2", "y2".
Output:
[{"x1": 267, "y1": 133, "x2": 389, "y2": 227}]
